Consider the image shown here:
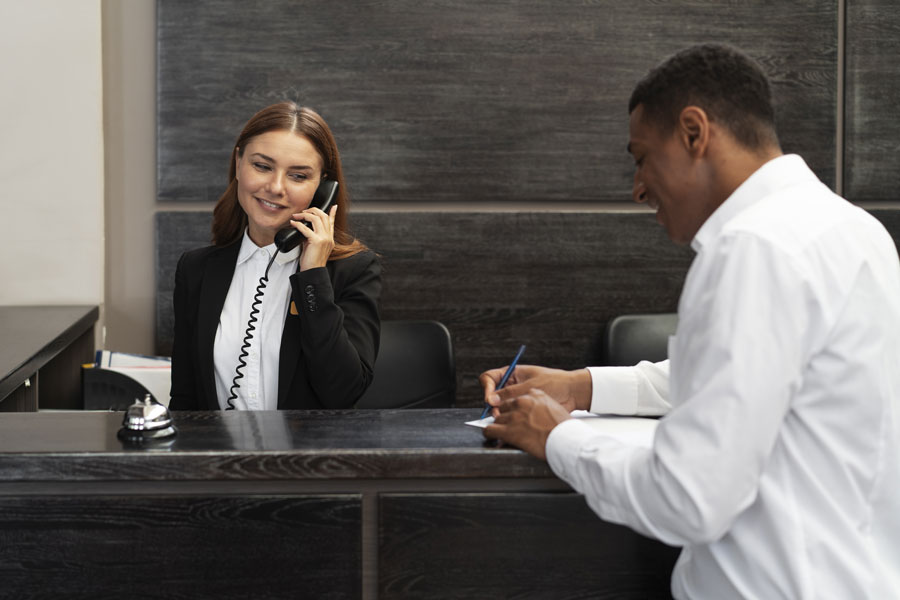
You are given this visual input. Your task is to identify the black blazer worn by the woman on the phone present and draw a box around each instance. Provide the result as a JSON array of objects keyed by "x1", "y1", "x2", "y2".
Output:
[{"x1": 169, "y1": 239, "x2": 381, "y2": 410}]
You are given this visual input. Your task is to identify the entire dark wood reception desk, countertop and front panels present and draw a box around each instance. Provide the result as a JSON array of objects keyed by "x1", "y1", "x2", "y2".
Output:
[{"x1": 0, "y1": 409, "x2": 678, "y2": 599}]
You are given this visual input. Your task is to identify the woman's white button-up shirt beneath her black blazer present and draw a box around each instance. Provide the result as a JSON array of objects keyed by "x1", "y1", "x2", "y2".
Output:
[{"x1": 213, "y1": 230, "x2": 300, "y2": 410}]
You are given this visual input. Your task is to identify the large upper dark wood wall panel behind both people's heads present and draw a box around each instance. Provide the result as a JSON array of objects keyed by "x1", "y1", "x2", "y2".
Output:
[{"x1": 157, "y1": 0, "x2": 837, "y2": 203}]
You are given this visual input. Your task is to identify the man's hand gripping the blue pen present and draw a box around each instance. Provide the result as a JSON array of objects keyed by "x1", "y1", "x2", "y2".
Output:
[{"x1": 479, "y1": 365, "x2": 592, "y2": 417}]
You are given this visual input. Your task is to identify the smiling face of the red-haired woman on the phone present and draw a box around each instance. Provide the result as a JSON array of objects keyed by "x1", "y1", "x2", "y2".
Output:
[{"x1": 235, "y1": 131, "x2": 322, "y2": 246}]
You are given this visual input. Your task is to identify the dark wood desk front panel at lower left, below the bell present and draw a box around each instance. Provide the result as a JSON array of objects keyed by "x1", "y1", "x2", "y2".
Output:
[{"x1": 0, "y1": 495, "x2": 362, "y2": 600}]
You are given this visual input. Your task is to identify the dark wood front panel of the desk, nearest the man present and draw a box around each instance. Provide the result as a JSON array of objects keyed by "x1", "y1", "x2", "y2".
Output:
[{"x1": 378, "y1": 494, "x2": 679, "y2": 600}]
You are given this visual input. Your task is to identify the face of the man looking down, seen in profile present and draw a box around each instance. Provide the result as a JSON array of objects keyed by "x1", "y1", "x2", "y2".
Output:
[{"x1": 628, "y1": 105, "x2": 712, "y2": 244}]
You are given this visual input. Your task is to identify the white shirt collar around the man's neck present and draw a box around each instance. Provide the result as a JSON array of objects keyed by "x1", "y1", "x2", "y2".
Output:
[{"x1": 691, "y1": 154, "x2": 816, "y2": 252}]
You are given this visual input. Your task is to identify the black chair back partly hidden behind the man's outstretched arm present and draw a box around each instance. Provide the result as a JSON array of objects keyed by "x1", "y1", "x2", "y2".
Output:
[{"x1": 603, "y1": 313, "x2": 678, "y2": 367}]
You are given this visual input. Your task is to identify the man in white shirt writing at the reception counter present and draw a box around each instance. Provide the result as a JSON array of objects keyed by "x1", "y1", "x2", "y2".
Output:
[{"x1": 481, "y1": 45, "x2": 900, "y2": 599}]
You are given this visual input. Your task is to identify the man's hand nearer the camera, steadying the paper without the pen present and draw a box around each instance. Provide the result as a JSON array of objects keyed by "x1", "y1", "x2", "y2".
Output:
[{"x1": 484, "y1": 390, "x2": 572, "y2": 460}]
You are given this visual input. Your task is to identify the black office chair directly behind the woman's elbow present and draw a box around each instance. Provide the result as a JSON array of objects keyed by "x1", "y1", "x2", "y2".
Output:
[{"x1": 356, "y1": 321, "x2": 456, "y2": 408}]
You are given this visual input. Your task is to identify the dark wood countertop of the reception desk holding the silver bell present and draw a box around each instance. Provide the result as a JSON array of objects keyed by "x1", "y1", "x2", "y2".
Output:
[{"x1": 0, "y1": 408, "x2": 556, "y2": 482}]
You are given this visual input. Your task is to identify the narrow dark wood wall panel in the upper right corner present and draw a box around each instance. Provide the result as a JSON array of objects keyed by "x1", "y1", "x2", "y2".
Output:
[{"x1": 844, "y1": 0, "x2": 900, "y2": 202}]
